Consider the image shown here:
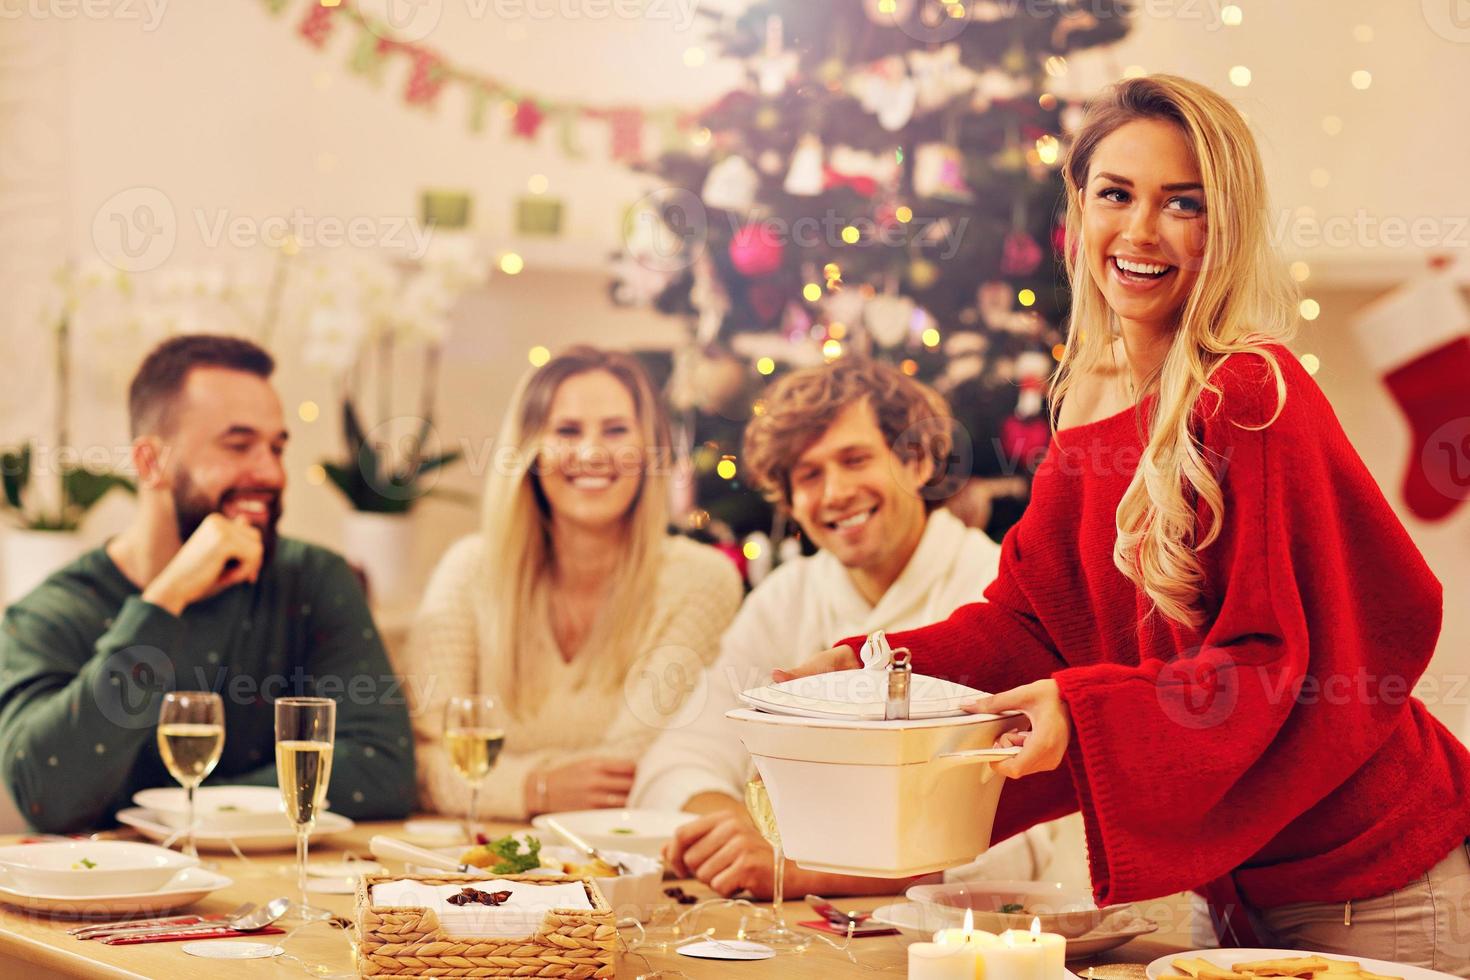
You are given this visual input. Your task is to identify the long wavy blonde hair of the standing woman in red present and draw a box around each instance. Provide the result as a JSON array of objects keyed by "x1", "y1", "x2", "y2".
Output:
[{"x1": 1051, "y1": 75, "x2": 1297, "y2": 626}]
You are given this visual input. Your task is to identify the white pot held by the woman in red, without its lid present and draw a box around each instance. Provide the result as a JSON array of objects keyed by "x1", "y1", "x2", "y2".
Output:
[{"x1": 725, "y1": 708, "x2": 1025, "y2": 877}]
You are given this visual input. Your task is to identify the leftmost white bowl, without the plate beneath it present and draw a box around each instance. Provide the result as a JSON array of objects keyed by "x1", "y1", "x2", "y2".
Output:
[{"x1": 0, "y1": 840, "x2": 198, "y2": 898}]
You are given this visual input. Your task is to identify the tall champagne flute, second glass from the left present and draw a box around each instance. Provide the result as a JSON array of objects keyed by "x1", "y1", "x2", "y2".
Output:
[{"x1": 276, "y1": 698, "x2": 337, "y2": 920}]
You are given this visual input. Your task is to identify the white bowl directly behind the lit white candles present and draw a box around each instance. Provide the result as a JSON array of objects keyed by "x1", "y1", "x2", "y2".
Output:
[{"x1": 904, "y1": 882, "x2": 1122, "y2": 939}]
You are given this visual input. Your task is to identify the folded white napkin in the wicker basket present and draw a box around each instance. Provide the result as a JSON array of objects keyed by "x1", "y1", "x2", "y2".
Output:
[{"x1": 372, "y1": 879, "x2": 592, "y2": 939}]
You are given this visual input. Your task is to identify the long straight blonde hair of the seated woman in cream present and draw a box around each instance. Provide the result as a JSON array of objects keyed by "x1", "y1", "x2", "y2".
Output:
[{"x1": 479, "y1": 345, "x2": 670, "y2": 714}]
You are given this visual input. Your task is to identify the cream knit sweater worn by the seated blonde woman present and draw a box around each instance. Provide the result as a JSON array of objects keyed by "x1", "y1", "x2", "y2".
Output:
[{"x1": 398, "y1": 535, "x2": 742, "y2": 820}]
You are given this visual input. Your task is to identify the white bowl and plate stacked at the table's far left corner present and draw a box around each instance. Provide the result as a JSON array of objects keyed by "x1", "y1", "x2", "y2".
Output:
[{"x1": 0, "y1": 840, "x2": 234, "y2": 917}]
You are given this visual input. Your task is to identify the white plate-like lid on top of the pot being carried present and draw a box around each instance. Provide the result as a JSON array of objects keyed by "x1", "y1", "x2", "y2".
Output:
[{"x1": 739, "y1": 670, "x2": 985, "y2": 720}]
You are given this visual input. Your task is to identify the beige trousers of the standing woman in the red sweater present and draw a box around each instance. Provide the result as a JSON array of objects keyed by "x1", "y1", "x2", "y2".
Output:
[{"x1": 1251, "y1": 842, "x2": 1470, "y2": 977}]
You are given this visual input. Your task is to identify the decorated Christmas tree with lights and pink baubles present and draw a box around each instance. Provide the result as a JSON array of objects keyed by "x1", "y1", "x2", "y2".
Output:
[{"x1": 613, "y1": 0, "x2": 1130, "y2": 552}]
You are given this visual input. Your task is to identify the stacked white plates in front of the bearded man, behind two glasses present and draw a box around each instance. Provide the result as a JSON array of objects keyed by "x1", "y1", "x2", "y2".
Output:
[{"x1": 118, "y1": 786, "x2": 353, "y2": 852}]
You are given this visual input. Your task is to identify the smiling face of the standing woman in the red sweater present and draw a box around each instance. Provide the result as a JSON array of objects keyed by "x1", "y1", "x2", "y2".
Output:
[{"x1": 1080, "y1": 119, "x2": 1207, "y2": 329}]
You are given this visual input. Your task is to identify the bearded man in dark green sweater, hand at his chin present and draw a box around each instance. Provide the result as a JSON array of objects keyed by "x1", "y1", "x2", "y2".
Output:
[{"x1": 0, "y1": 335, "x2": 415, "y2": 832}]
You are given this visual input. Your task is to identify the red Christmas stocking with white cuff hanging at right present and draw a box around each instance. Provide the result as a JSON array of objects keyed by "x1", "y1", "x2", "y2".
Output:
[{"x1": 1354, "y1": 275, "x2": 1470, "y2": 520}]
